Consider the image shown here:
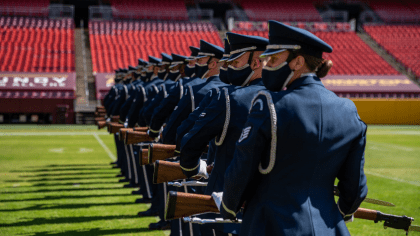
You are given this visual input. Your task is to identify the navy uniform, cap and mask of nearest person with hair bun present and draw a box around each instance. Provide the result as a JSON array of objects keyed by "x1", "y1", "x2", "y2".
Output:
[{"x1": 220, "y1": 21, "x2": 367, "y2": 235}]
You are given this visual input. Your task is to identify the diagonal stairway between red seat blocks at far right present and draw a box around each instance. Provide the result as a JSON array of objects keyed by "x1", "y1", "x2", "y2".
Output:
[{"x1": 357, "y1": 29, "x2": 420, "y2": 85}]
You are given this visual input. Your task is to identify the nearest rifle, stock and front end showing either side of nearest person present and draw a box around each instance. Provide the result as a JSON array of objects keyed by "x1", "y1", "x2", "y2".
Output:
[{"x1": 165, "y1": 191, "x2": 420, "y2": 235}]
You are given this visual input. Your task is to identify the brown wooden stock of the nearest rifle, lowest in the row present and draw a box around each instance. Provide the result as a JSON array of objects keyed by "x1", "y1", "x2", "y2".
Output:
[{"x1": 165, "y1": 191, "x2": 219, "y2": 220}]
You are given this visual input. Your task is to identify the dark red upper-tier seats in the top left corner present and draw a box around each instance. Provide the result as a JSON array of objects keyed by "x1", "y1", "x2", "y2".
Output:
[{"x1": 0, "y1": 0, "x2": 50, "y2": 16}]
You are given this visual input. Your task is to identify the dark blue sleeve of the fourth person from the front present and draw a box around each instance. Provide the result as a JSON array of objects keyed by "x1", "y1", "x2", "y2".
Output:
[{"x1": 150, "y1": 83, "x2": 183, "y2": 135}]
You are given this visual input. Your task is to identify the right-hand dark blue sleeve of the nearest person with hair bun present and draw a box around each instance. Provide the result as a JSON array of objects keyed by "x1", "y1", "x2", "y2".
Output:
[{"x1": 337, "y1": 116, "x2": 368, "y2": 216}]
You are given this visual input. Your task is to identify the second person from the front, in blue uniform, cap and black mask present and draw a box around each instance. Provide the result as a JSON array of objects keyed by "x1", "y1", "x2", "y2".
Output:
[{"x1": 178, "y1": 32, "x2": 268, "y2": 235}]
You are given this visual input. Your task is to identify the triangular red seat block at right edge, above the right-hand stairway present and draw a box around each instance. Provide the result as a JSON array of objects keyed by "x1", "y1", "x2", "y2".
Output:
[{"x1": 364, "y1": 25, "x2": 420, "y2": 77}]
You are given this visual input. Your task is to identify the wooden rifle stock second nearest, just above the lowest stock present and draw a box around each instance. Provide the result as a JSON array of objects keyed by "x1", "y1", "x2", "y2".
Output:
[{"x1": 153, "y1": 160, "x2": 213, "y2": 184}]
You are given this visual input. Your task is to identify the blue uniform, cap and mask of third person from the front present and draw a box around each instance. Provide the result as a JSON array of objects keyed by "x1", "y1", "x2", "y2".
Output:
[{"x1": 162, "y1": 40, "x2": 226, "y2": 144}]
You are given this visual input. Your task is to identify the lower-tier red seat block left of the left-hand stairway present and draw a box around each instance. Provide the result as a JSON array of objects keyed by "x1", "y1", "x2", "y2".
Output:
[{"x1": 0, "y1": 17, "x2": 75, "y2": 72}]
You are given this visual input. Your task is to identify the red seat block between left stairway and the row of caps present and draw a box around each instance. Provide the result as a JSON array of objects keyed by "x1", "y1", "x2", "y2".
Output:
[{"x1": 89, "y1": 21, "x2": 222, "y2": 72}]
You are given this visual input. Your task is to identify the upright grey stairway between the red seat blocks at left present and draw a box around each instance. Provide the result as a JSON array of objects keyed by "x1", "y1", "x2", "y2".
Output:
[{"x1": 74, "y1": 28, "x2": 97, "y2": 124}]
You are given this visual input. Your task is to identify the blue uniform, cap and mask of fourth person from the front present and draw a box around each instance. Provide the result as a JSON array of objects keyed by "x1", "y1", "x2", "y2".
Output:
[{"x1": 149, "y1": 47, "x2": 204, "y2": 137}]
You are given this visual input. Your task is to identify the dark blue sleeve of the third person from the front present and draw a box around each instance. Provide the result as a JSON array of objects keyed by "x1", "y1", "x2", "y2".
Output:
[{"x1": 162, "y1": 95, "x2": 191, "y2": 144}]
